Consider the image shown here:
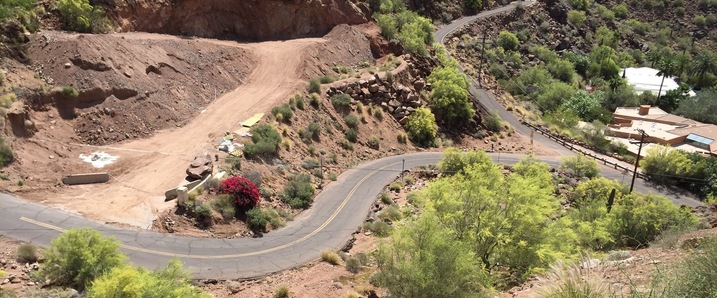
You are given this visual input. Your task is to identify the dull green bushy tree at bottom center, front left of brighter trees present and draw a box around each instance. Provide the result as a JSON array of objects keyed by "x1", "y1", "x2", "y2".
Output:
[{"x1": 376, "y1": 212, "x2": 490, "y2": 298}]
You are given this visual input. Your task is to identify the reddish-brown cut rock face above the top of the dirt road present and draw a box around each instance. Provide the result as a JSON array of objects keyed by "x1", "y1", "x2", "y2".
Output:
[{"x1": 105, "y1": 0, "x2": 367, "y2": 40}]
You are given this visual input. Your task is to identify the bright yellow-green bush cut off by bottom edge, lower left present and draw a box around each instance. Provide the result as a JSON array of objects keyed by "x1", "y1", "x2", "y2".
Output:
[{"x1": 87, "y1": 260, "x2": 211, "y2": 298}]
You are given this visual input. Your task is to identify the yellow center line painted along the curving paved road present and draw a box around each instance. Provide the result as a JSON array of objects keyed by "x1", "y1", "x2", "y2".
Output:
[{"x1": 20, "y1": 158, "x2": 398, "y2": 259}]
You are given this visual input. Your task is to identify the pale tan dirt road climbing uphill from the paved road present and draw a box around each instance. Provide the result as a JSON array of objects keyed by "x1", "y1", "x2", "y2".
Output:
[{"x1": 48, "y1": 33, "x2": 324, "y2": 228}]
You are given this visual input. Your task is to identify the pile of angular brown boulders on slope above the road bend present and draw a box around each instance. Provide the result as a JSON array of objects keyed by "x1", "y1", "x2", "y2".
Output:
[{"x1": 326, "y1": 74, "x2": 431, "y2": 124}]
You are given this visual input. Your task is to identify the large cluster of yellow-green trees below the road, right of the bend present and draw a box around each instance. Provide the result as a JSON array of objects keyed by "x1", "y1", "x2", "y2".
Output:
[{"x1": 372, "y1": 150, "x2": 697, "y2": 297}]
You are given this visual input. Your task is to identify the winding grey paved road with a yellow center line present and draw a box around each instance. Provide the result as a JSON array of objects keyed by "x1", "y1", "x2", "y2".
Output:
[{"x1": 0, "y1": 0, "x2": 699, "y2": 279}]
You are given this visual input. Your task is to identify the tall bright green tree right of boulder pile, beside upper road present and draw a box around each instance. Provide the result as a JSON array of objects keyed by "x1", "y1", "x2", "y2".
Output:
[{"x1": 428, "y1": 67, "x2": 475, "y2": 124}]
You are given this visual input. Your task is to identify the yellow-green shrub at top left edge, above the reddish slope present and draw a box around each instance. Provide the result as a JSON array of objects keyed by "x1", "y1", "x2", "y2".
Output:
[{"x1": 55, "y1": 0, "x2": 111, "y2": 33}]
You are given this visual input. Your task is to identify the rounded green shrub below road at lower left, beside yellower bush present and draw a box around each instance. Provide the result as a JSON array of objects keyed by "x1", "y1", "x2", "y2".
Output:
[{"x1": 40, "y1": 228, "x2": 125, "y2": 290}]
